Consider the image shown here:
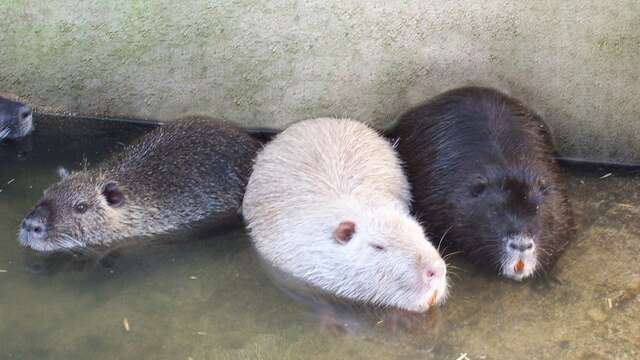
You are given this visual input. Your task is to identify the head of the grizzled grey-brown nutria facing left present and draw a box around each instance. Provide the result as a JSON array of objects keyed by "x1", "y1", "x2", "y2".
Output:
[{"x1": 19, "y1": 169, "x2": 138, "y2": 252}]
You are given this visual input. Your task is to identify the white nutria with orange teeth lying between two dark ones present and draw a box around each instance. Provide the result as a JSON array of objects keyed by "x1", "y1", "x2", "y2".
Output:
[{"x1": 242, "y1": 118, "x2": 447, "y2": 312}]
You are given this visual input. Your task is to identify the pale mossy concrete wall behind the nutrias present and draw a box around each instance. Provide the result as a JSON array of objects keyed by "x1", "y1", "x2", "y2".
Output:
[{"x1": 0, "y1": 0, "x2": 640, "y2": 163}]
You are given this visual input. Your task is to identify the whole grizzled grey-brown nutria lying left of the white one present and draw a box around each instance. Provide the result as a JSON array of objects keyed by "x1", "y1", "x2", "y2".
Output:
[{"x1": 19, "y1": 117, "x2": 259, "y2": 251}]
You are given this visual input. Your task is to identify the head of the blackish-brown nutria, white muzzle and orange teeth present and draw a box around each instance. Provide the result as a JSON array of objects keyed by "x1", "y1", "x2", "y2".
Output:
[{"x1": 445, "y1": 166, "x2": 568, "y2": 280}]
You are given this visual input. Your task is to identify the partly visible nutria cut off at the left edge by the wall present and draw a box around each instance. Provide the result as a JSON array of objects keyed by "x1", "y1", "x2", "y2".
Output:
[{"x1": 0, "y1": 94, "x2": 34, "y2": 142}]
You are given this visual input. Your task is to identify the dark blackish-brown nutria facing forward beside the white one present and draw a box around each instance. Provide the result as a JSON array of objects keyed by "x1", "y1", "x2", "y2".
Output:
[{"x1": 390, "y1": 87, "x2": 573, "y2": 280}]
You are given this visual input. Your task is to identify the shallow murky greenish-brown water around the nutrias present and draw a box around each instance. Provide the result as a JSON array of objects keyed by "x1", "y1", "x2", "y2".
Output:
[{"x1": 0, "y1": 117, "x2": 640, "y2": 360}]
